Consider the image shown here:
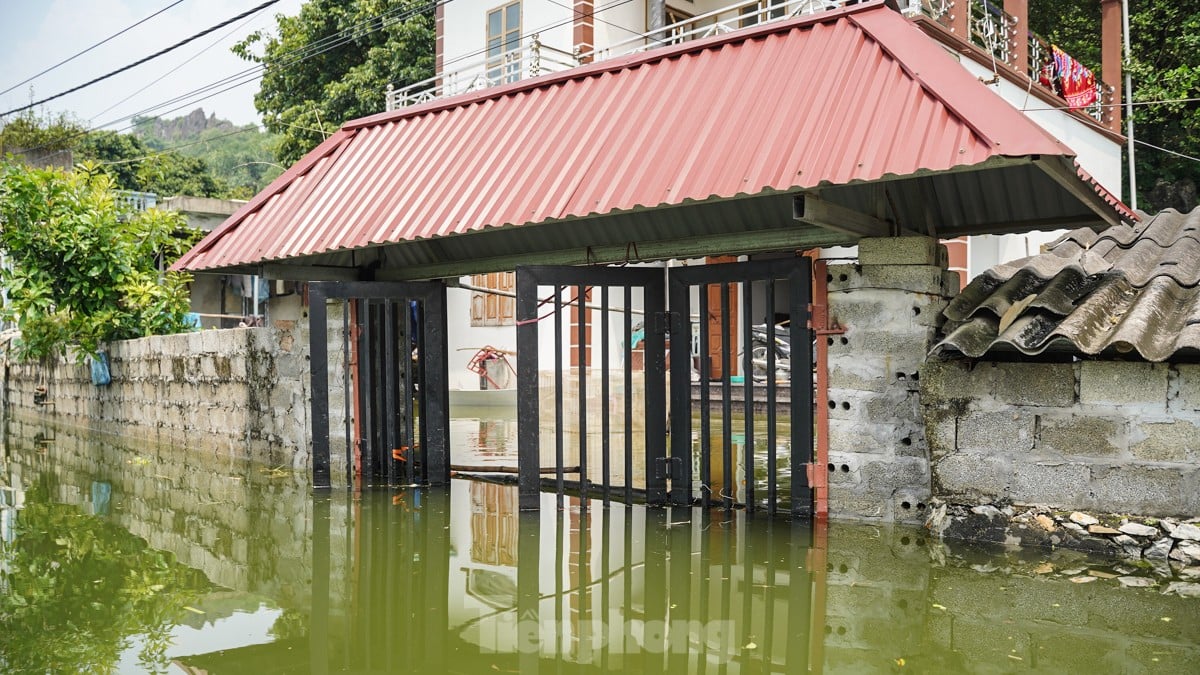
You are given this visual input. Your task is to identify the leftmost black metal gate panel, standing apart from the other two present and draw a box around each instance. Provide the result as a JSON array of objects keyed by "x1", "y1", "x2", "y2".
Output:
[{"x1": 308, "y1": 281, "x2": 450, "y2": 488}]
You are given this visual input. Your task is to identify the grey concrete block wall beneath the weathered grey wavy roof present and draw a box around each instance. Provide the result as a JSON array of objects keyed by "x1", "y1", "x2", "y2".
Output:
[{"x1": 920, "y1": 360, "x2": 1200, "y2": 516}]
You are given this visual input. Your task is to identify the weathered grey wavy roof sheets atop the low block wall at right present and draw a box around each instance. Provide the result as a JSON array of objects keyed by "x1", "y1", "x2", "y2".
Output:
[{"x1": 935, "y1": 209, "x2": 1200, "y2": 362}]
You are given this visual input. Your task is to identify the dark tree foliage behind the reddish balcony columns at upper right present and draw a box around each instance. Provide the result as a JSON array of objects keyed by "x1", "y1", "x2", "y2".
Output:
[{"x1": 1030, "y1": 0, "x2": 1200, "y2": 213}]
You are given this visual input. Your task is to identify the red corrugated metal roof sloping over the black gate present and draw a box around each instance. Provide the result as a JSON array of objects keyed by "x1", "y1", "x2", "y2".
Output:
[{"x1": 175, "y1": 2, "x2": 1123, "y2": 270}]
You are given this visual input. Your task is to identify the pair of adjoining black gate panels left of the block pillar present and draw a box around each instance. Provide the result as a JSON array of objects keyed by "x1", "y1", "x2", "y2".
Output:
[{"x1": 516, "y1": 256, "x2": 814, "y2": 516}]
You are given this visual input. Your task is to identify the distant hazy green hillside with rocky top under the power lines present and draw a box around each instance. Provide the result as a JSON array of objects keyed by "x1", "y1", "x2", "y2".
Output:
[{"x1": 133, "y1": 108, "x2": 283, "y2": 199}]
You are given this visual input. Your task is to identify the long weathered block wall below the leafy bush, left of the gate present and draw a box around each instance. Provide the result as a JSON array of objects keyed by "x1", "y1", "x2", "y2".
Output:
[{"x1": 4, "y1": 321, "x2": 310, "y2": 468}]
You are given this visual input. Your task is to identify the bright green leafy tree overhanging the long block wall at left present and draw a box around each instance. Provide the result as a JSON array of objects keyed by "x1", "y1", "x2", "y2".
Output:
[{"x1": 0, "y1": 162, "x2": 199, "y2": 359}]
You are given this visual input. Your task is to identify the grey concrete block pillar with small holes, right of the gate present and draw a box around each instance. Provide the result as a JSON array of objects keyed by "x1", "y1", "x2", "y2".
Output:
[{"x1": 817, "y1": 237, "x2": 959, "y2": 522}]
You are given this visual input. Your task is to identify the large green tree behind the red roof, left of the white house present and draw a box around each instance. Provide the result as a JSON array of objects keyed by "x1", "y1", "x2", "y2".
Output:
[{"x1": 234, "y1": 0, "x2": 434, "y2": 165}]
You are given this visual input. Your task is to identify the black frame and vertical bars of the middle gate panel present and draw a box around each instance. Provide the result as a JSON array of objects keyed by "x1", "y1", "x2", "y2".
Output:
[{"x1": 516, "y1": 265, "x2": 668, "y2": 510}]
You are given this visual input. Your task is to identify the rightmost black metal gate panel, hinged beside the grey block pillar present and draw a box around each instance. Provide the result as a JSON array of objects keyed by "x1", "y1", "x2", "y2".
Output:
[{"x1": 668, "y1": 256, "x2": 812, "y2": 515}]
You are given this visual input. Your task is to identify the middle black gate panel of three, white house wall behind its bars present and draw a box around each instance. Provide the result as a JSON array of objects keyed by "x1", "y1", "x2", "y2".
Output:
[{"x1": 516, "y1": 265, "x2": 667, "y2": 510}]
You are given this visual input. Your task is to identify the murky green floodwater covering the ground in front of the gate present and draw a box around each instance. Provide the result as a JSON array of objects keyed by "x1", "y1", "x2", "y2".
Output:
[{"x1": 0, "y1": 419, "x2": 1200, "y2": 675}]
